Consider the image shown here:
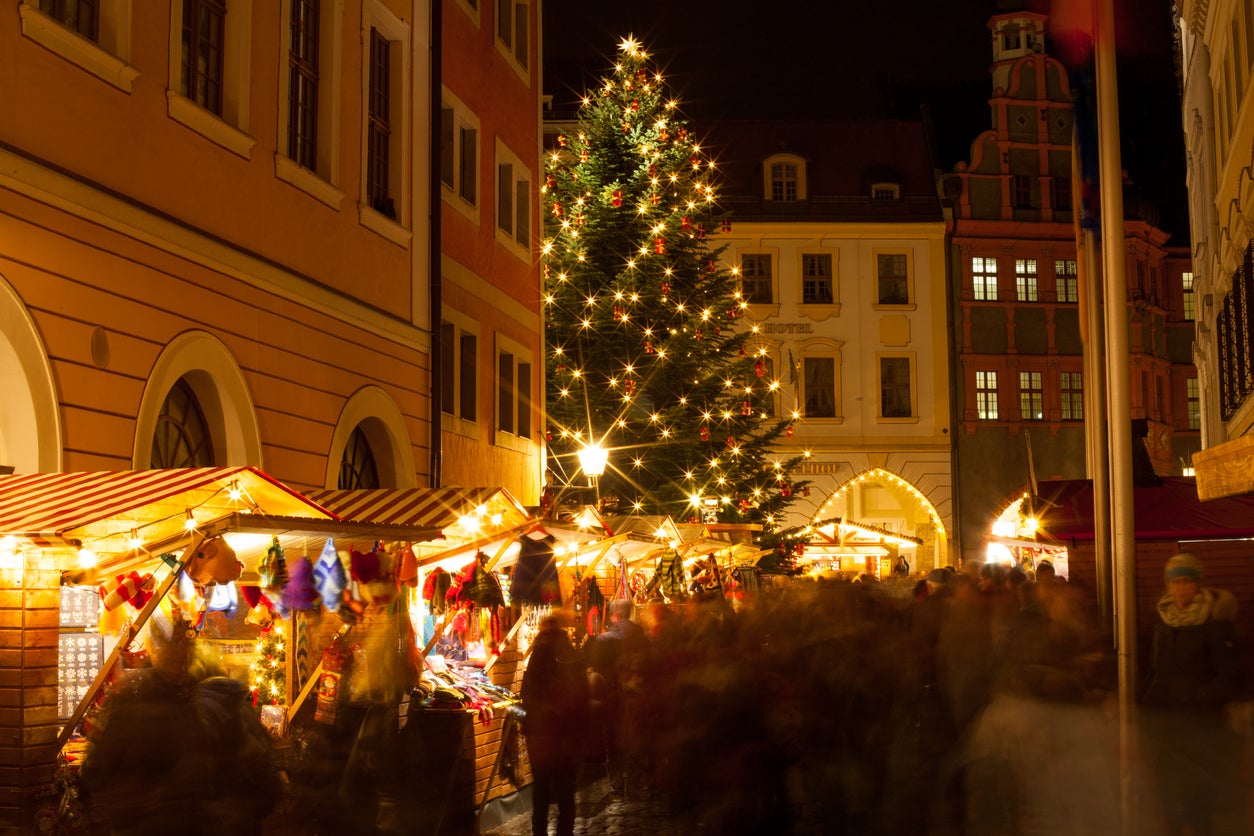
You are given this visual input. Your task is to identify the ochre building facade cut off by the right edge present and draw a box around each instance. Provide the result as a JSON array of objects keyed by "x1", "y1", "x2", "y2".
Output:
[{"x1": 1176, "y1": 0, "x2": 1254, "y2": 499}]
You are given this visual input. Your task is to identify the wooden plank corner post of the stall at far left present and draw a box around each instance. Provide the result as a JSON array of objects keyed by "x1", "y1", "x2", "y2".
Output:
[{"x1": 0, "y1": 558, "x2": 61, "y2": 832}]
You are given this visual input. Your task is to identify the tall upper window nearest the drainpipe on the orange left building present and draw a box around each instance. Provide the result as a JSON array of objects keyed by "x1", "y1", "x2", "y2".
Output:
[{"x1": 360, "y1": 0, "x2": 410, "y2": 235}]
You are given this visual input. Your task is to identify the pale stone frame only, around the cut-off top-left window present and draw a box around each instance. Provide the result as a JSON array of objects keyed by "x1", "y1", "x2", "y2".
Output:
[{"x1": 18, "y1": 0, "x2": 139, "y2": 93}]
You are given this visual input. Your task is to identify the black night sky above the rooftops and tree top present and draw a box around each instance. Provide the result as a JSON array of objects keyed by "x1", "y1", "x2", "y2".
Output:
[{"x1": 543, "y1": 0, "x2": 1189, "y2": 243}]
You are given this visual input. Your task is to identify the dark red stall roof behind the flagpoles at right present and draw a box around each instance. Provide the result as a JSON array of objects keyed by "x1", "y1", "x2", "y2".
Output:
[{"x1": 1036, "y1": 476, "x2": 1254, "y2": 540}]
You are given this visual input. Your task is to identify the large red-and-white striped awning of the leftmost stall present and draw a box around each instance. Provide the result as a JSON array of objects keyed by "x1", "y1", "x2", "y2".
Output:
[{"x1": 0, "y1": 466, "x2": 335, "y2": 555}]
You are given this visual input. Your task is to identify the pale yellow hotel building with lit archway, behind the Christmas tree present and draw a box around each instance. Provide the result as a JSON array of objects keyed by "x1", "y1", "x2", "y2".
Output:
[{"x1": 697, "y1": 119, "x2": 954, "y2": 575}]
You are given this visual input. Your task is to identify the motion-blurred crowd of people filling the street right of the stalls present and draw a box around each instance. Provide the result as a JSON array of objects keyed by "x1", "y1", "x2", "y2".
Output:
[{"x1": 523, "y1": 555, "x2": 1251, "y2": 836}]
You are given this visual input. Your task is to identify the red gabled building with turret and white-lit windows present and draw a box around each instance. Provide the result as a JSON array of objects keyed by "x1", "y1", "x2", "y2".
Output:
[{"x1": 941, "y1": 11, "x2": 1199, "y2": 556}]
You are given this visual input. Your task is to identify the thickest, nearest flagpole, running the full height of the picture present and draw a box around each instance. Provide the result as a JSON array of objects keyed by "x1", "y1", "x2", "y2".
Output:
[{"x1": 1095, "y1": 0, "x2": 1136, "y2": 836}]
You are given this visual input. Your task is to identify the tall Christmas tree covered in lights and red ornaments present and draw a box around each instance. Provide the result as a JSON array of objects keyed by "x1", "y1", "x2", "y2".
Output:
[{"x1": 542, "y1": 38, "x2": 803, "y2": 541}]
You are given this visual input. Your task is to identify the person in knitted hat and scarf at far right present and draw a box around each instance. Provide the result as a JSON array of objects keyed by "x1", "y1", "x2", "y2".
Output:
[{"x1": 1141, "y1": 551, "x2": 1239, "y2": 835}]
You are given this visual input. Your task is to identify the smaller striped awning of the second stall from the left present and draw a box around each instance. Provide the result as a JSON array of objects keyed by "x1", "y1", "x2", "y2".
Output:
[{"x1": 305, "y1": 488, "x2": 530, "y2": 538}]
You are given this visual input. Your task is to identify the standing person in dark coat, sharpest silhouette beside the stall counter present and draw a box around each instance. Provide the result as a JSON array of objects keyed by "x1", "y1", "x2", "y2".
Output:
[{"x1": 522, "y1": 615, "x2": 591, "y2": 836}]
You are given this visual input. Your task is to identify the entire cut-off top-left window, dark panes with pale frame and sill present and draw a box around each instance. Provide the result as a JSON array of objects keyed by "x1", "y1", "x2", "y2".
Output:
[{"x1": 18, "y1": 0, "x2": 139, "y2": 93}]
